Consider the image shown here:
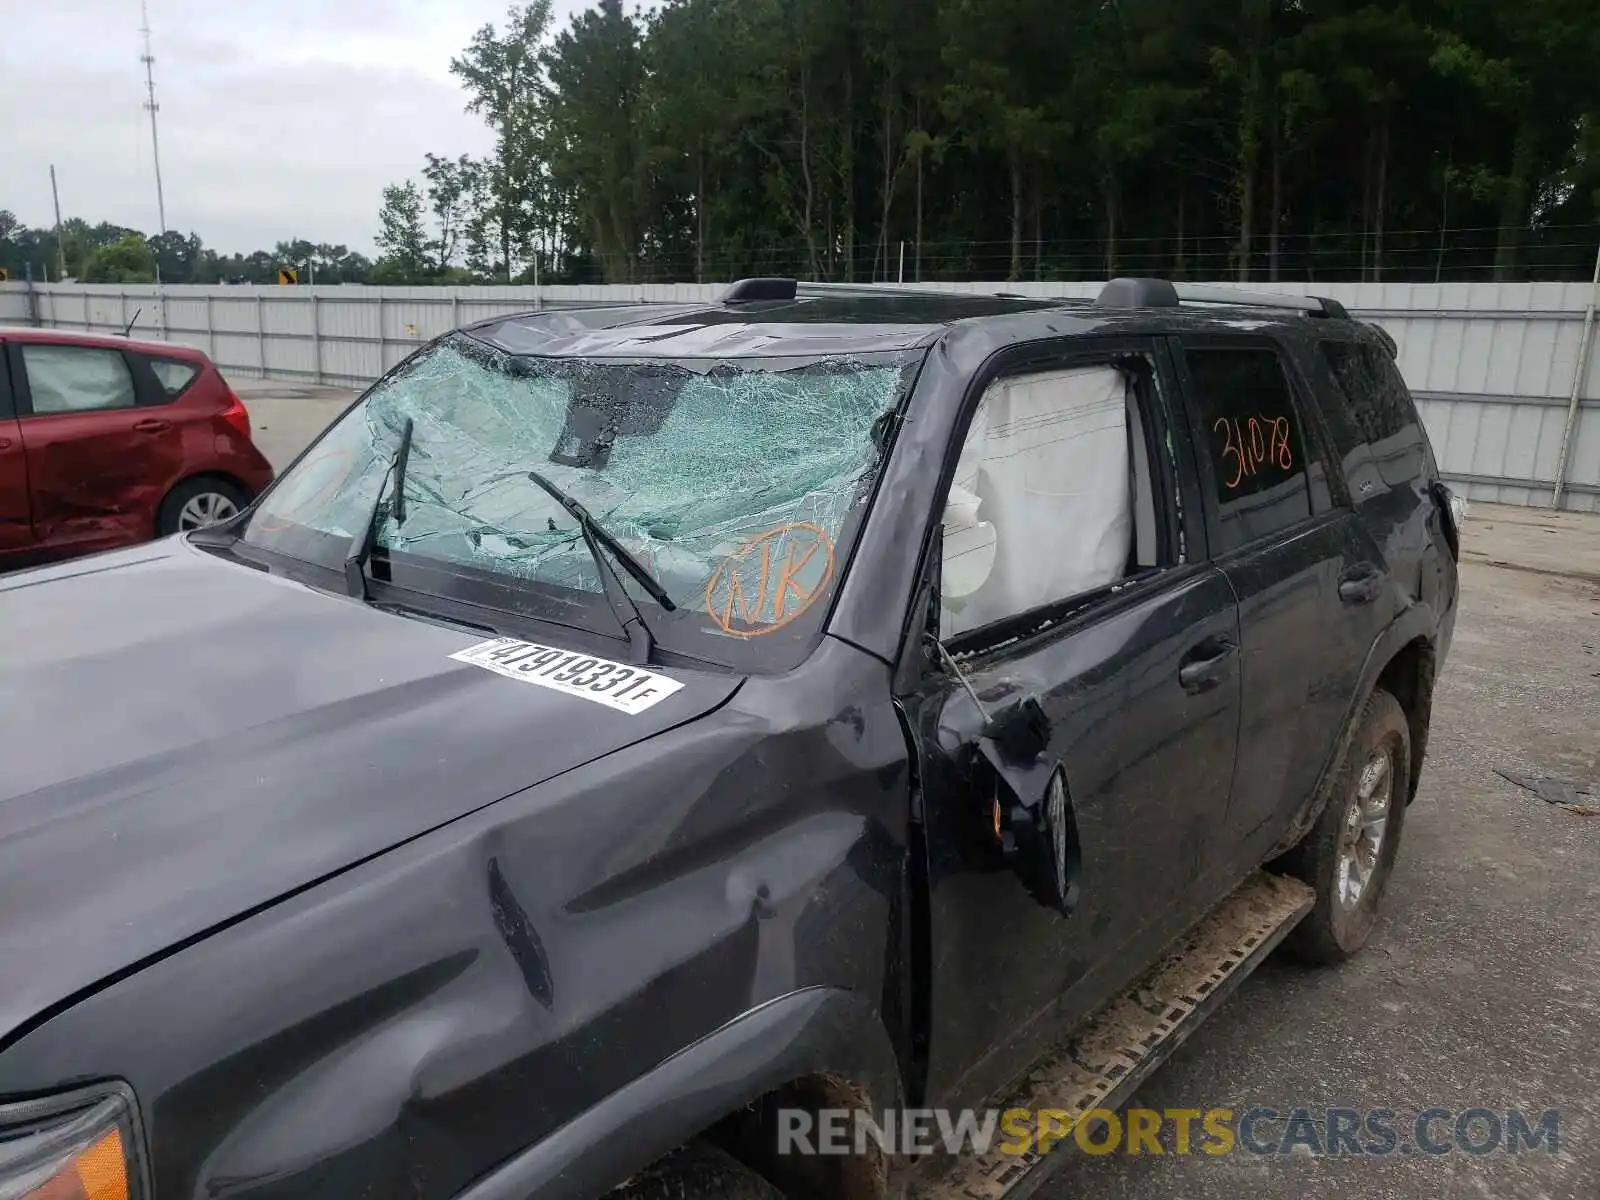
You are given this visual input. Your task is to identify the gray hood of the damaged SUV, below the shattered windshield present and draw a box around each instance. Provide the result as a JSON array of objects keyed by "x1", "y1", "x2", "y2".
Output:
[{"x1": 0, "y1": 539, "x2": 741, "y2": 1043}]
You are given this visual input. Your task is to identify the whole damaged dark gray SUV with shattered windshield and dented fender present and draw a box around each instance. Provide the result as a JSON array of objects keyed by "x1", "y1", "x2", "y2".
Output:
[{"x1": 0, "y1": 280, "x2": 1459, "y2": 1200}]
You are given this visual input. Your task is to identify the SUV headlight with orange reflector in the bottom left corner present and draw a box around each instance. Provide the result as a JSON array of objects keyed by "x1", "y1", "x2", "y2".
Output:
[{"x1": 0, "y1": 1085, "x2": 146, "y2": 1200}]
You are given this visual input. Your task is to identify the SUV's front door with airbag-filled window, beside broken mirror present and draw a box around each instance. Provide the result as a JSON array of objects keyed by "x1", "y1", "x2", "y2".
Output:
[{"x1": 902, "y1": 347, "x2": 1238, "y2": 1104}]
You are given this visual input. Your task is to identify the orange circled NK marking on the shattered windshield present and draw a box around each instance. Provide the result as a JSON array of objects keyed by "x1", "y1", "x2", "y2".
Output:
[{"x1": 706, "y1": 522, "x2": 834, "y2": 637}]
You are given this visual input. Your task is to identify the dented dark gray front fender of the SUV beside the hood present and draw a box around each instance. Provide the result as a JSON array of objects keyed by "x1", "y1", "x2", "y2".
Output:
[{"x1": 0, "y1": 642, "x2": 909, "y2": 1200}]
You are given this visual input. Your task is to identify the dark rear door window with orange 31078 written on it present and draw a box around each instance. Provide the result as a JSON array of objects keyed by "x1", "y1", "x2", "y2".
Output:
[{"x1": 1184, "y1": 346, "x2": 1310, "y2": 550}]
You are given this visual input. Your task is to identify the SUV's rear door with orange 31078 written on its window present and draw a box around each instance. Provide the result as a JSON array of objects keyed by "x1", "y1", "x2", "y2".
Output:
[{"x1": 1176, "y1": 336, "x2": 1386, "y2": 869}]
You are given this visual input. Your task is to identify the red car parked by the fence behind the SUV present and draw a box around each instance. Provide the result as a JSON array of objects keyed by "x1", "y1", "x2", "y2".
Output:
[{"x1": 0, "y1": 326, "x2": 272, "y2": 570}]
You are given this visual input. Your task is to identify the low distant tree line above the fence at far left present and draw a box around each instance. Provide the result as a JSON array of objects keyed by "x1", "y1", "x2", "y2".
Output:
[{"x1": 0, "y1": 208, "x2": 372, "y2": 283}]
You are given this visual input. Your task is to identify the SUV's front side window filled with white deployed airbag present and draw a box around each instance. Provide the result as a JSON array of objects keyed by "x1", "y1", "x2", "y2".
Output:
[{"x1": 941, "y1": 365, "x2": 1171, "y2": 638}]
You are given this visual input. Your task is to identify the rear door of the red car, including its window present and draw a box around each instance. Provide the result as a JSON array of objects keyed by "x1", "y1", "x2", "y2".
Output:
[{"x1": 10, "y1": 342, "x2": 182, "y2": 549}]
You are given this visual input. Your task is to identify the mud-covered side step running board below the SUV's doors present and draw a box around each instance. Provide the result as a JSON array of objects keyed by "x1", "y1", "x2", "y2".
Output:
[{"x1": 909, "y1": 870, "x2": 1314, "y2": 1200}]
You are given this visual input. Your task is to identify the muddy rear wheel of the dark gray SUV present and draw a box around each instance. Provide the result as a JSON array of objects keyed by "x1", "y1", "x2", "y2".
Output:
[{"x1": 1280, "y1": 690, "x2": 1411, "y2": 963}]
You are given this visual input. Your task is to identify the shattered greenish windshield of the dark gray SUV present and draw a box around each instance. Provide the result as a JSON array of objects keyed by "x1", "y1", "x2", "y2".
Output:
[{"x1": 243, "y1": 334, "x2": 910, "y2": 662}]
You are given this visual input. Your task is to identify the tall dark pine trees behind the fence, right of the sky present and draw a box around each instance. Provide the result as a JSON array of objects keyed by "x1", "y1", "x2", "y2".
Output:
[{"x1": 378, "y1": 0, "x2": 1600, "y2": 282}]
